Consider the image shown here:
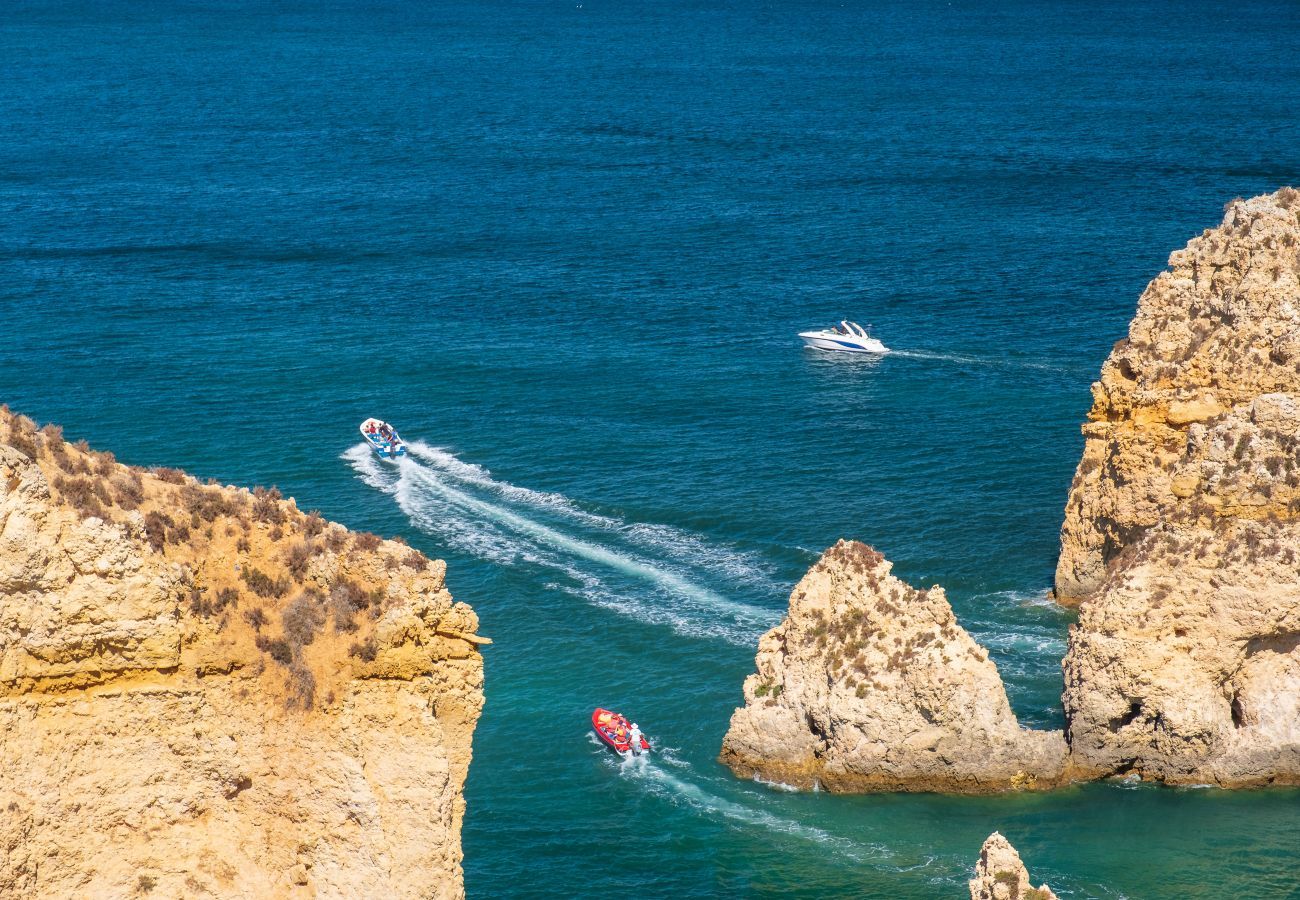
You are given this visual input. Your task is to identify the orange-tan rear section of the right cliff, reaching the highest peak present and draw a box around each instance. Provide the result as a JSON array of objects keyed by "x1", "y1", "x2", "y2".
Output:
[{"x1": 1056, "y1": 189, "x2": 1300, "y2": 603}]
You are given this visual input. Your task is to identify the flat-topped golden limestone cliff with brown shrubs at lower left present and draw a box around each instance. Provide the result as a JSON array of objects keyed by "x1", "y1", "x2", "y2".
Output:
[{"x1": 0, "y1": 408, "x2": 485, "y2": 897}]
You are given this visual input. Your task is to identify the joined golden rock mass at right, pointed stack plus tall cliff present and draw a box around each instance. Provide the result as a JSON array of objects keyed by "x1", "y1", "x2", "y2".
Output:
[{"x1": 722, "y1": 189, "x2": 1300, "y2": 792}]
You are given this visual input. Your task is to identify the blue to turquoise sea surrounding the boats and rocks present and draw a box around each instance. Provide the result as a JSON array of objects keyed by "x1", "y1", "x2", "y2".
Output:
[{"x1": 0, "y1": 0, "x2": 1300, "y2": 897}]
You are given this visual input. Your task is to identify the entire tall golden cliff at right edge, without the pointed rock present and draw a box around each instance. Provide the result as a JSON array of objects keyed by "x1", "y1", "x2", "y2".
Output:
[{"x1": 1057, "y1": 189, "x2": 1300, "y2": 786}]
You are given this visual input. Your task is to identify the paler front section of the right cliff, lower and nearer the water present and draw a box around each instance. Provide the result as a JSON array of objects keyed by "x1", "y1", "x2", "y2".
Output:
[{"x1": 1065, "y1": 394, "x2": 1300, "y2": 786}]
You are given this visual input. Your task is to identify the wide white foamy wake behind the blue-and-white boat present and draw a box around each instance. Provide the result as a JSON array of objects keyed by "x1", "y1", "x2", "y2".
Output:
[{"x1": 343, "y1": 441, "x2": 787, "y2": 646}]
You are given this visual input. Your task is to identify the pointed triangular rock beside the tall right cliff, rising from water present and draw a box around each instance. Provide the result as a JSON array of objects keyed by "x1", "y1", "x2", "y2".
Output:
[{"x1": 722, "y1": 541, "x2": 1066, "y2": 793}]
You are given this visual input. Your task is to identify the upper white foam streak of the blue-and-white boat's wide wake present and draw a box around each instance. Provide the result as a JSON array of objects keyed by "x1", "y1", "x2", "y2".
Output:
[{"x1": 407, "y1": 441, "x2": 788, "y2": 594}]
